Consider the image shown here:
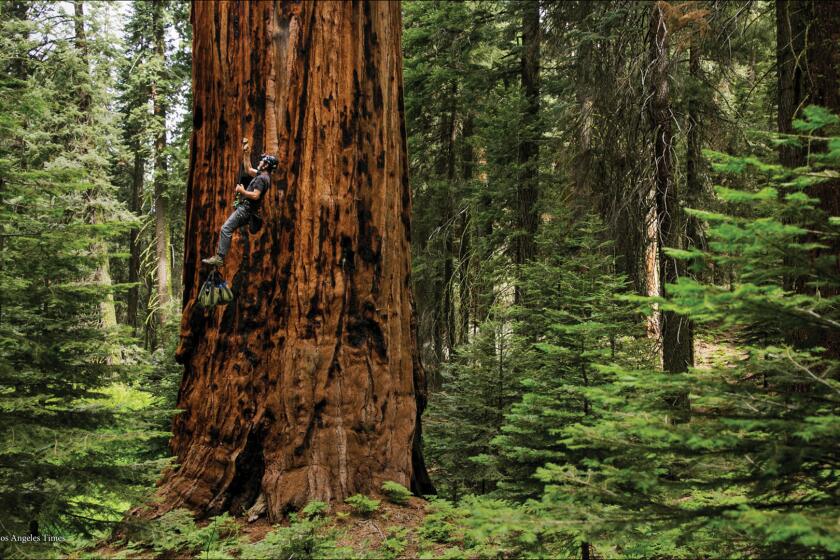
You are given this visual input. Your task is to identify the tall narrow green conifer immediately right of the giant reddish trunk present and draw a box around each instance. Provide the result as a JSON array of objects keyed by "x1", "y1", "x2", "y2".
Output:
[{"x1": 403, "y1": 2, "x2": 493, "y2": 376}]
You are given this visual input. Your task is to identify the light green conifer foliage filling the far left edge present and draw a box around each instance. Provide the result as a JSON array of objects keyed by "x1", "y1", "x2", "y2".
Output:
[{"x1": 0, "y1": 2, "x2": 167, "y2": 557}]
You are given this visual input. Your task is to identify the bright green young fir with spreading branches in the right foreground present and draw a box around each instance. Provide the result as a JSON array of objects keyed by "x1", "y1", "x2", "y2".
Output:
[{"x1": 539, "y1": 109, "x2": 840, "y2": 558}]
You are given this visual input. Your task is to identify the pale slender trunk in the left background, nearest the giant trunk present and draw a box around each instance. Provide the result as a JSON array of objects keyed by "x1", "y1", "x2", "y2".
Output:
[{"x1": 152, "y1": 2, "x2": 172, "y2": 328}]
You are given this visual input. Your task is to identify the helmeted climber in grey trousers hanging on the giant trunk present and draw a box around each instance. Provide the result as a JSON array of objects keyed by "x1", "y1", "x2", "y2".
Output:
[{"x1": 201, "y1": 139, "x2": 279, "y2": 266}]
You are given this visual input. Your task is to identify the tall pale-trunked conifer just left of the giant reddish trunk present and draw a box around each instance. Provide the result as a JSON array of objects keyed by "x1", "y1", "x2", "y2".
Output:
[{"x1": 117, "y1": 2, "x2": 192, "y2": 348}]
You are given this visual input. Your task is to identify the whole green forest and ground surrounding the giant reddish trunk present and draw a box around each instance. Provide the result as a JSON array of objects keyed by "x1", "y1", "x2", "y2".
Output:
[{"x1": 0, "y1": 0, "x2": 840, "y2": 560}]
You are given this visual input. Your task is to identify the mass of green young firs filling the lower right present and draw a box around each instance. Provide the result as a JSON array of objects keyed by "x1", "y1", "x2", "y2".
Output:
[{"x1": 422, "y1": 108, "x2": 840, "y2": 558}]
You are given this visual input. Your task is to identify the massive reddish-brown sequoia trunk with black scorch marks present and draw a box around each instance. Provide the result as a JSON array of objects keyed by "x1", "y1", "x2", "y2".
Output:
[{"x1": 135, "y1": 1, "x2": 432, "y2": 521}]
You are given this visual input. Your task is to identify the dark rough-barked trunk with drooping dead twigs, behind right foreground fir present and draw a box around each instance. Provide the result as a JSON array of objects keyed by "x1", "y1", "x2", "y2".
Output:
[{"x1": 649, "y1": 2, "x2": 693, "y2": 372}]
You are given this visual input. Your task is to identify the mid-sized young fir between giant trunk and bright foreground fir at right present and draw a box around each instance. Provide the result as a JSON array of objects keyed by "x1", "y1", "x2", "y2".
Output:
[{"x1": 486, "y1": 217, "x2": 652, "y2": 500}]
